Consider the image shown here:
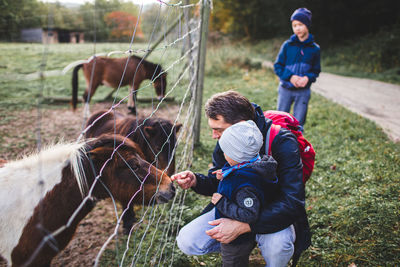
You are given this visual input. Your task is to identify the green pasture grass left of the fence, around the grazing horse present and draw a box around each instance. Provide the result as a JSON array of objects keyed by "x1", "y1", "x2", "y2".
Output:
[{"x1": 0, "y1": 43, "x2": 183, "y2": 108}]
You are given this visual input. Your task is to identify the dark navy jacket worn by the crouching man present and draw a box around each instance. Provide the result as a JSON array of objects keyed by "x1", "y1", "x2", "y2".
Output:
[{"x1": 193, "y1": 104, "x2": 311, "y2": 261}]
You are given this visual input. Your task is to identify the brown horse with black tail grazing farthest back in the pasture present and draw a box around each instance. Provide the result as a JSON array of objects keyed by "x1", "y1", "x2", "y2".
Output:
[{"x1": 72, "y1": 56, "x2": 167, "y2": 114}]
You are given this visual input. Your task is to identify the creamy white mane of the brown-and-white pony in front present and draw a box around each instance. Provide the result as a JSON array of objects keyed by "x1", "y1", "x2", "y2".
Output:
[{"x1": 3, "y1": 141, "x2": 88, "y2": 197}]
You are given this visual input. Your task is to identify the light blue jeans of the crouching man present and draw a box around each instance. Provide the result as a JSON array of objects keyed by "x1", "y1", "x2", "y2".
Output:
[{"x1": 176, "y1": 209, "x2": 296, "y2": 267}]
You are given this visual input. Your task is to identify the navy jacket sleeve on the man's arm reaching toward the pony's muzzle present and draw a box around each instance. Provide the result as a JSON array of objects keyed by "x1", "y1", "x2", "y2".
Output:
[{"x1": 192, "y1": 143, "x2": 226, "y2": 196}]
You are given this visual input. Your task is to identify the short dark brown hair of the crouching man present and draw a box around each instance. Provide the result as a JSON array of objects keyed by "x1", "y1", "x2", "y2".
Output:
[{"x1": 205, "y1": 90, "x2": 255, "y2": 124}]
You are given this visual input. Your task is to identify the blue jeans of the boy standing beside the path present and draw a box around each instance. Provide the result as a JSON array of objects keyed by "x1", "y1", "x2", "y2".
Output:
[{"x1": 277, "y1": 85, "x2": 311, "y2": 127}]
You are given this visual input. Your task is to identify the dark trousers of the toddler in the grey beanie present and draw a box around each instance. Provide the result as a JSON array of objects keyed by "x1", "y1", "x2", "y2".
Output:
[{"x1": 221, "y1": 239, "x2": 256, "y2": 267}]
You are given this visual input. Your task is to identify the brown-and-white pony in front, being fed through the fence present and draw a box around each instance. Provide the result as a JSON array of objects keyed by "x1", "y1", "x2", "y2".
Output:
[{"x1": 0, "y1": 134, "x2": 175, "y2": 267}]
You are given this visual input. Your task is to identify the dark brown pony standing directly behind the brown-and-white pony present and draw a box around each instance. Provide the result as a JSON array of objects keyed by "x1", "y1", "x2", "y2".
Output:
[{"x1": 85, "y1": 110, "x2": 182, "y2": 234}]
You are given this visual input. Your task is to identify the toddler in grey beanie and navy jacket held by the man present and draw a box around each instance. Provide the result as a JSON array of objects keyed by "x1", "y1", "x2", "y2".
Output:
[{"x1": 178, "y1": 120, "x2": 278, "y2": 267}]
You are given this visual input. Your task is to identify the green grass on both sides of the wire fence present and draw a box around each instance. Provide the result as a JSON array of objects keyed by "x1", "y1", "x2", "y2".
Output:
[{"x1": 0, "y1": 43, "x2": 400, "y2": 266}]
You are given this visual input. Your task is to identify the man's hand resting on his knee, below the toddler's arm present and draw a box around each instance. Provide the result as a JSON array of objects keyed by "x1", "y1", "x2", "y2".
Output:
[{"x1": 206, "y1": 218, "x2": 251, "y2": 244}]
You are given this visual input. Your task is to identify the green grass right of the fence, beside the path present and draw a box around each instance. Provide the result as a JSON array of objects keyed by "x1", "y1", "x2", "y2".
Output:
[{"x1": 185, "y1": 49, "x2": 400, "y2": 266}]
